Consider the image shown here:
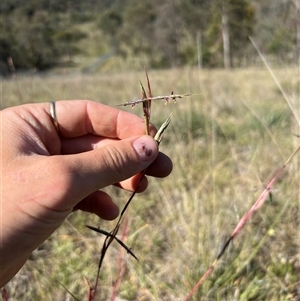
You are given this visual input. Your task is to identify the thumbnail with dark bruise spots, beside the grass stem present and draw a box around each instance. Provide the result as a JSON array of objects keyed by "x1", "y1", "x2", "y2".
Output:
[{"x1": 132, "y1": 136, "x2": 157, "y2": 162}]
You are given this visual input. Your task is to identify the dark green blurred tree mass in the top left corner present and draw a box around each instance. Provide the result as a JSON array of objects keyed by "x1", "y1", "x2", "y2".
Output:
[{"x1": 0, "y1": 0, "x2": 102, "y2": 74}]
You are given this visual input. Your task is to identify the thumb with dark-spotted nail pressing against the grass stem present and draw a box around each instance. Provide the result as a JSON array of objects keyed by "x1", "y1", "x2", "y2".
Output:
[{"x1": 64, "y1": 135, "x2": 158, "y2": 201}]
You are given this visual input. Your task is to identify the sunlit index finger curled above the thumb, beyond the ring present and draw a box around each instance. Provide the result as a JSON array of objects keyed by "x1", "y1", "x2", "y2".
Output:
[{"x1": 50, "y1": 100, "x2": 156, "y2": 139}]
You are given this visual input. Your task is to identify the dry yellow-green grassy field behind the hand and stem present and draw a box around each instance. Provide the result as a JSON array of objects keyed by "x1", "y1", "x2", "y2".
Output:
[{"x1": 1, "y1": 69, "x2": 300, "y2": 301}]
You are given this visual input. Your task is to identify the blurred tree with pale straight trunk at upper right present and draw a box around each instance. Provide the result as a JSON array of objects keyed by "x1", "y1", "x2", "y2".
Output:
[{"x1": 180, "y1": 0, "x2": 255, "y2": 68}]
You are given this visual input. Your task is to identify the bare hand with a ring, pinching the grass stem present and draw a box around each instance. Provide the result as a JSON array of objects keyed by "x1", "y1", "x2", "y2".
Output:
[{"x1": 0, "y1": 100, "x2": 172, "y2": 287}]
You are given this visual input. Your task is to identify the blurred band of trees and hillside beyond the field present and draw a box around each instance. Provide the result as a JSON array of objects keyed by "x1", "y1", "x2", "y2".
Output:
[{"x1": 0, "y1": 0, "x2": 300, "y2": 75}]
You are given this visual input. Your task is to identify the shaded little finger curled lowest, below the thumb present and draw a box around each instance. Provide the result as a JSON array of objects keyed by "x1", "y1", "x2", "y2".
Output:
[{"x1": 74, "y1": 191, "x2": 119, "y2": 220}]
